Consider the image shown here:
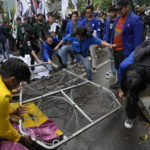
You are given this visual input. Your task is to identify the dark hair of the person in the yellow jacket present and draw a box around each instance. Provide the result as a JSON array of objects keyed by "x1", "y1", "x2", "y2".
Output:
[{"x1": 0, "y1": 58, "x2": 31, "y2": 82}]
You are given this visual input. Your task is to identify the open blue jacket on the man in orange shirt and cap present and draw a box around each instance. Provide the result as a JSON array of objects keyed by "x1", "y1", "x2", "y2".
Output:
[{"x1": 111, "y1": 12, "x2": 144, "y2": 57}]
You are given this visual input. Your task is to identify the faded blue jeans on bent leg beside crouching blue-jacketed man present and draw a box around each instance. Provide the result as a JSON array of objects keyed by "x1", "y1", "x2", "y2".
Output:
[{"x1": 61, "y1": 45, "x2": 75, "y2": 66}]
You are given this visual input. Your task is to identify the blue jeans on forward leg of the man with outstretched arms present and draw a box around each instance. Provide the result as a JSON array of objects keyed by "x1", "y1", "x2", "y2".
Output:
[{"x1": 76, "y1": 54, "x2": 92, "y2": 81}]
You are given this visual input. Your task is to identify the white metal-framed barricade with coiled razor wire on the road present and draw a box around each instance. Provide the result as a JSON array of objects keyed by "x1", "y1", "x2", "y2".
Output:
[{"x1": 15, "y1": 62, "x2": 121, "y2": 149}]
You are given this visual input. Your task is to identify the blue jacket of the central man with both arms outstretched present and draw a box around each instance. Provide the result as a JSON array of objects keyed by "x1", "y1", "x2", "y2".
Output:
[{"x1": 63, "y1": 35, "x2": 102, "y2": 57}]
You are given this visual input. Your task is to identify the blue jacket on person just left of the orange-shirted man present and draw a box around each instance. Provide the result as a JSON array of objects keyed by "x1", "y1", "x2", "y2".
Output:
[{"x1": 104, "y1": 18, "x2": 115, "y2": 42}]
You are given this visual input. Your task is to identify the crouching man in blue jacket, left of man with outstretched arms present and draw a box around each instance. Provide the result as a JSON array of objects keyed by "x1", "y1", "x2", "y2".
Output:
[{"x1": 42, "y1": 35, "x2": 61, "y2": 72}]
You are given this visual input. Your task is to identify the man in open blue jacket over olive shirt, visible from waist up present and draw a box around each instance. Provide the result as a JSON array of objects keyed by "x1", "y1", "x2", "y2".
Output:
[{"x1": 65, "y1": 11, "x2": 82, "y2": 35}]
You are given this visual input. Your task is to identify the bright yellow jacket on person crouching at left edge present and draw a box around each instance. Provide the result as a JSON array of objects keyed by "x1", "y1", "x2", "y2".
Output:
[{"x1": 0, "y1": 76, "x2": 21, "y2": 142}]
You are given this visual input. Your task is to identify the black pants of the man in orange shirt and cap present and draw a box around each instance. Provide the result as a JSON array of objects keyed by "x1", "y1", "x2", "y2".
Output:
[{"x1": 114, "y1": 50, "x2": 124, "y2": 70}]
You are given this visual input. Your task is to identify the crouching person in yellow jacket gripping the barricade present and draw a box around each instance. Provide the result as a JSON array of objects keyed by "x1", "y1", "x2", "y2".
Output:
[{"x1": 0, "y1": 58, "x2": 31, "y2": 144}]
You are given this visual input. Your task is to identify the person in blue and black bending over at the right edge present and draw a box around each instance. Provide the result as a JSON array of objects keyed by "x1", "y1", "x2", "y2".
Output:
[{"x1": 119, "y1": 39, "x2": 150, "y2": 128}]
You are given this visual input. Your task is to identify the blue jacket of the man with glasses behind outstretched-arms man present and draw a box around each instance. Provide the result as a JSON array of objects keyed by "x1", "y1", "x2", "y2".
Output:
[{"x1": 82, "y1": 17, "x2": 101, "y2": 37}]
